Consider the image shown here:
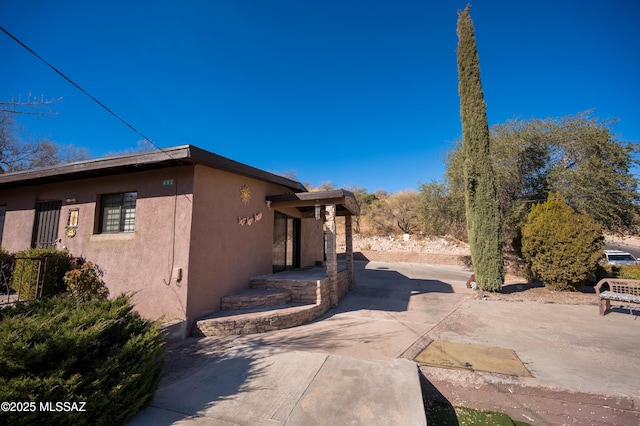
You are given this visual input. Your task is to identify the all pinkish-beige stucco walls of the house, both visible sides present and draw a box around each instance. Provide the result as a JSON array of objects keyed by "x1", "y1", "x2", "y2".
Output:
[{"x1": 0, "y1": 166, "x2": 324, "y2": 332}]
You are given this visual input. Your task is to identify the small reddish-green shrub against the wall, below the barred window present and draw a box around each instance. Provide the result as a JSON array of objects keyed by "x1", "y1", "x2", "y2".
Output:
[{"x1": 63, "y1": 257, "x2": 109, "y2": 302}]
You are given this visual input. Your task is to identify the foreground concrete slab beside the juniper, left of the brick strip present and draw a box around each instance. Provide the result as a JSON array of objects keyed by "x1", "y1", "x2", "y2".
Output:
[{"x1": 131, "y1": 348, "x2": 426, "y2": 425}]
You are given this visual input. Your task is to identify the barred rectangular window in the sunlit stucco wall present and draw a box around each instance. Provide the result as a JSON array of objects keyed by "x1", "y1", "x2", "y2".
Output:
[{"x1": 100, "y1": 192, "x2": 138, "y2": 234}]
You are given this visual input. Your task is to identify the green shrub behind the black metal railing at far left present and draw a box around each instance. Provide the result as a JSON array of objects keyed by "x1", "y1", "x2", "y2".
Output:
[{"x1": 11, "y1": 249, "x2": 71, "y2": 300}]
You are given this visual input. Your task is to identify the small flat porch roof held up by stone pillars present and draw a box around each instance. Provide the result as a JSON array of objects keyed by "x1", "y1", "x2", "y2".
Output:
[{"x1": 266, "y1": 189, "x2": 360, "y2": 217}]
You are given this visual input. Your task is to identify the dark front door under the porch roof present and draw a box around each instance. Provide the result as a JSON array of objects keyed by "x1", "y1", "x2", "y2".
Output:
[{"x1": 273, "y1": 212, "x2": 301, "y2": 272}]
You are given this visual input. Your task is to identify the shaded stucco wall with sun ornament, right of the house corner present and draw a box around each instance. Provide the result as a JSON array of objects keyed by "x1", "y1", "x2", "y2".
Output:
[{"x1": 187, "y1": 166, "x2": 323, "y2": 321}]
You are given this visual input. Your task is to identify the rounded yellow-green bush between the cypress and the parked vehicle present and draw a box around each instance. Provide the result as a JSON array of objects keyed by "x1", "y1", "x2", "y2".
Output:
[{"x1": 522, "y1": 197, "x2": 604, "y2": 290}]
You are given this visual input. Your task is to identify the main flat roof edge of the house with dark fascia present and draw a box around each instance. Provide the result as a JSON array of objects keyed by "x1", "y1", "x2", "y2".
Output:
[{"x1": 0, "y1": 145, "x2": 307, "y2": 192}]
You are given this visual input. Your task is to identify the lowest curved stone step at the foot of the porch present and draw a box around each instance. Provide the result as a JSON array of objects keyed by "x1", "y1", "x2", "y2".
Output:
[{"x1": 191, "y1": 303, "x2": 329, "y2": 337}]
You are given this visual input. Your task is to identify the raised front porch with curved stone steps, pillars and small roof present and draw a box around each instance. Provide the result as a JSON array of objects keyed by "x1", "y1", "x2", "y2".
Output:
[{"x1": 191, "y1": 189, "x2": 360, "y2": 336}]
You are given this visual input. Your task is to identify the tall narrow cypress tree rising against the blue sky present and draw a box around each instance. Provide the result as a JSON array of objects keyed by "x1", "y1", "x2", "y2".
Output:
[{"x1": 457, "y1": 5, "x2": 504, "y2": 291}]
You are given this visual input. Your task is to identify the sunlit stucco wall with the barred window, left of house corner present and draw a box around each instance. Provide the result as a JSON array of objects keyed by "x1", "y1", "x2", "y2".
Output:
[{"x1": 0, "y1": 167, "x2": 193, "y2": 320}]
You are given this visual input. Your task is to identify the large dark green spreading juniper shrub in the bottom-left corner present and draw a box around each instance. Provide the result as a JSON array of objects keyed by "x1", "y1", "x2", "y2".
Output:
[{"x1": 0, "y1": 295, "x2": 163, "y2": 425}]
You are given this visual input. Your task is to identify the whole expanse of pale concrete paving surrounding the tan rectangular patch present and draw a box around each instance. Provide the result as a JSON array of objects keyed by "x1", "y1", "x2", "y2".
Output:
[{"x1": 130, "y1": 262, "x2": 640, "y2": 425}]
